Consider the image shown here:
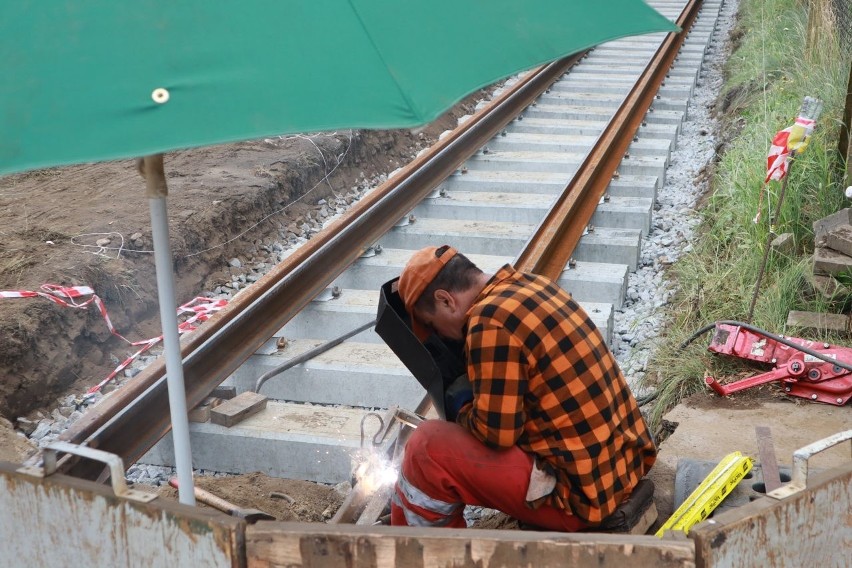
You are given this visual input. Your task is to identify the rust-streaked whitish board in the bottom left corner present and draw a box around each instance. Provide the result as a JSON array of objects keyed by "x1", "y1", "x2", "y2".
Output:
[{"x1": 0, "y1": 462, "x2": 245, "y2": 568}]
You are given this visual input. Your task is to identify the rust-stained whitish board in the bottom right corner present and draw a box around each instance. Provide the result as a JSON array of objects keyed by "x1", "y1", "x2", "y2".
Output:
[{"x1": 689, "y1": 462, "x2": 852, "y2": 568}]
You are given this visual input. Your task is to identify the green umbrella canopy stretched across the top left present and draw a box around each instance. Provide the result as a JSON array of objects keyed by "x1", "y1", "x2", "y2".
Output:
[{"x1": 0, "y1": 0, "x2": 677, "y2": 173}]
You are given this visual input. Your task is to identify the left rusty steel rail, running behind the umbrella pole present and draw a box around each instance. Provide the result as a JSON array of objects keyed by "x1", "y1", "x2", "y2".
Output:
[{"x1": 60, "y1": 56, "x2": 580, "y2": 479}]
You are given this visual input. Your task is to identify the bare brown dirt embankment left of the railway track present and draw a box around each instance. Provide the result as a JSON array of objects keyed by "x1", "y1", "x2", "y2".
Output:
[{"x1": 0, "y1": 93, "x2": 484, "y2": 442}]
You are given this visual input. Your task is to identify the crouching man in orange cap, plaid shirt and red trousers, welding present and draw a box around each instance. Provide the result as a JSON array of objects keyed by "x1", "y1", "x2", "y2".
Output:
[{"x1": 391, "y1": 245, "x2": 656, "y2": 532}]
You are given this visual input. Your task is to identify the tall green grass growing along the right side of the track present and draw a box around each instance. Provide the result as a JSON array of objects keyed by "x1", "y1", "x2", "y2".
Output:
[{"x1": 645, "y1": 0, "x2": 852, "y2": 427}]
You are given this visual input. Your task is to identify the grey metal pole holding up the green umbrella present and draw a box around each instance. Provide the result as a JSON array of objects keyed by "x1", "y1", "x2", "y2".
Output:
[{"x1": 138, "y1": 154, "x2": 195, "y2": 505}]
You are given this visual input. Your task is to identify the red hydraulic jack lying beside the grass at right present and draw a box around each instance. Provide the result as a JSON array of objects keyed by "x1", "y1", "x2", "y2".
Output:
[{"x1": 704, "y1": 322, "x2": 852, "y2": 406}]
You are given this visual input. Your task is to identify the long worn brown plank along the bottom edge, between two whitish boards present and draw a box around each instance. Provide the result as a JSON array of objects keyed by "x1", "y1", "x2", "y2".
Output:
[{"x1": 246, "y1": 522, "x2": 695, "y2": 568}]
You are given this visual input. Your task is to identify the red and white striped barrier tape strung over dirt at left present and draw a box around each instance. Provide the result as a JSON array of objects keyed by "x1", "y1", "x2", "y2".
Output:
[{"x1": 0, "y1": 284, "x2": 228, "y2": 394}]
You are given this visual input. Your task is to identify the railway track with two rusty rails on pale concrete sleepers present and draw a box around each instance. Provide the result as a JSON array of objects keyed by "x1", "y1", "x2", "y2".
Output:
[{"x1": 60, "y1": 0, "x2": 721, "y2": 523}]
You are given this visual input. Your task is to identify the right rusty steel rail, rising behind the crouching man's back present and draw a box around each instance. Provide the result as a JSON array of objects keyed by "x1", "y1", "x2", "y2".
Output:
[{"x1": 515, "y1": 0, "x2": 701, "y2": 280}]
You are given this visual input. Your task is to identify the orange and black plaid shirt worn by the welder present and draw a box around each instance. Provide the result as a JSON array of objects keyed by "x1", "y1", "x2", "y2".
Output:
[{"x1": 457, "y1": 265, "x2": 657, "y2": 525}]
